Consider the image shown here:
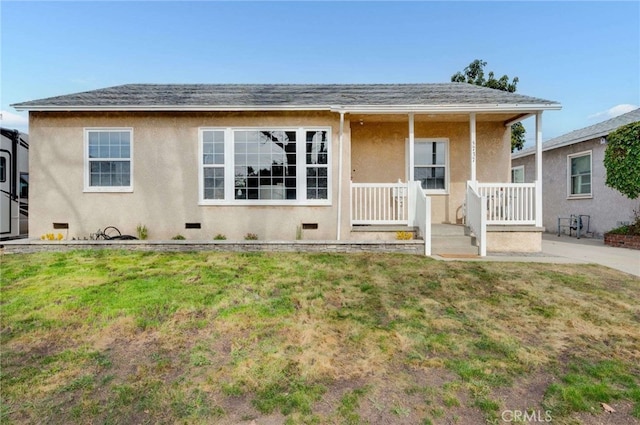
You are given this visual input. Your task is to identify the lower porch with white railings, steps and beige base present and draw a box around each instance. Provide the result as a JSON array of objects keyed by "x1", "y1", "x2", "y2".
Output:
[{"x1": 350, "y1": 181, "x2": 543, "y2": 256}]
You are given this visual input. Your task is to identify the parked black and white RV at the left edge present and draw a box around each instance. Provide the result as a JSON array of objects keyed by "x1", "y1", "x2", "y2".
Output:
[{"x1": 0, "y1": 128, "x2": 29, "y2": 240}]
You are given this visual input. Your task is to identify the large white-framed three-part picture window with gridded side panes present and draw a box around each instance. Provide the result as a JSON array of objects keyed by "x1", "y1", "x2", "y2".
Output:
[{"x1": 200, "y1": 128, "x2": 330, "y2": 205}]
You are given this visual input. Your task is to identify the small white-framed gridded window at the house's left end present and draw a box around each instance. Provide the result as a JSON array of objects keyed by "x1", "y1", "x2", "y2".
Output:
[{"x1": 85, "y1": 129, "x2": 133, "y2": 192}]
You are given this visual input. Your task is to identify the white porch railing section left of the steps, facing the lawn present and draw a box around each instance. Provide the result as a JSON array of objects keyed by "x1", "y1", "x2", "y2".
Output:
[{"x1": 351, "y1": 182, "x2": 409, "y2": 225}]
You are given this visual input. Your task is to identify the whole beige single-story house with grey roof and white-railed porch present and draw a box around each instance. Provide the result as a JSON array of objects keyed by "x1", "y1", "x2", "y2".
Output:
[{"x1": 13, "y1": 83, "x2": 560, "y2": 254}]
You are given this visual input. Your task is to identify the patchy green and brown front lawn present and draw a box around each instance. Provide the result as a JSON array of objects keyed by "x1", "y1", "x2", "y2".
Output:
[{"x1": 0, "y1": 251, "x2": 640, "y2": 425}]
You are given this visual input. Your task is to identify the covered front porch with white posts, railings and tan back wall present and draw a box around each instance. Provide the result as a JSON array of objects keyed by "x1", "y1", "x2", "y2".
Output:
[{"x1": 348, "y1": 111, "x2": 543, "y2": 256}]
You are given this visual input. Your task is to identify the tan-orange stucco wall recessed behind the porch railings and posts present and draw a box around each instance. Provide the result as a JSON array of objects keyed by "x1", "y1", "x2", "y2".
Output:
[{"x1": 351, "y1": 121, "x2": 511, "y2": 223}]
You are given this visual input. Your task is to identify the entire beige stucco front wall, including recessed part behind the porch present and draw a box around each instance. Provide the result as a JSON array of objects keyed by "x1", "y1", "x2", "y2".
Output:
[{"x1": 29, "y1": 112, "x2": 510, "y2": 240}]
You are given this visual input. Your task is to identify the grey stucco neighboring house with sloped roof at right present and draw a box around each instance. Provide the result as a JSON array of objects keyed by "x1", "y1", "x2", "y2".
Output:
[{"x1": 511, "y1": 109, "x2": 640, "y2": 237}]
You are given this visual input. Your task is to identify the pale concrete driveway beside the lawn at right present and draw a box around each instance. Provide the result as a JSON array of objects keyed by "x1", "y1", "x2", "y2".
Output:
[{"x1": 542, "y1": 233, "x2": 640, "y2": 276}]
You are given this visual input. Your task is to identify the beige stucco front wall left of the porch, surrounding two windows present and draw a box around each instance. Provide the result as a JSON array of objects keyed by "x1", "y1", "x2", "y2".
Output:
[{"x1": 29, "y1": 113, "x2": 348, "y2": 240}]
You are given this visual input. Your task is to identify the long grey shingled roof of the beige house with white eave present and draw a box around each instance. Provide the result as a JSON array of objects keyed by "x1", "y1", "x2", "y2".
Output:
[{"x1": 12, "y1": 83, "x2": 560, "y2": 112}]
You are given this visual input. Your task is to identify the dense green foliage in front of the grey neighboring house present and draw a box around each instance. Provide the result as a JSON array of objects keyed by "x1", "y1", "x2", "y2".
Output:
[{"x1": 604, "y1": 121, "x2": 640, "y2": 199}]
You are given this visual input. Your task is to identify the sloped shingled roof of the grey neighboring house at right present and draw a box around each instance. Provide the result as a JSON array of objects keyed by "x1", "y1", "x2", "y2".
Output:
[{"x1": 511, "y1": 108, "x2": 640, "y2": 158}]
